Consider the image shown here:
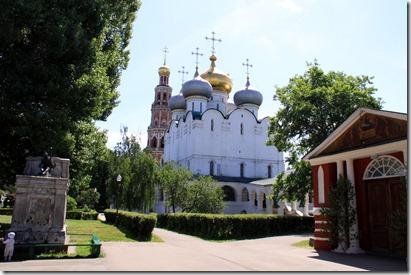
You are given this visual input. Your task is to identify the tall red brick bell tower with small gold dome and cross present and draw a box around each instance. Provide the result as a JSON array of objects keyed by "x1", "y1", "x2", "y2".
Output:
[{"x1": 147, "y1": 48, "x2": 172, "y2": 162}]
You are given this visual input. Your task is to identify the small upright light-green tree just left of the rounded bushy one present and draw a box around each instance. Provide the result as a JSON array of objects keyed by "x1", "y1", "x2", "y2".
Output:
[{"x1": 156, "y1": 162, "x2": 193, "y2": 213}]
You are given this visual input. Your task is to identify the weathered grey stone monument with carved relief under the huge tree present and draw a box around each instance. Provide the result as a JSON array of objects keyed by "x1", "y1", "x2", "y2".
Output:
[{"x1": 8, "y1": 156, "x2": 70, "y2": 244}]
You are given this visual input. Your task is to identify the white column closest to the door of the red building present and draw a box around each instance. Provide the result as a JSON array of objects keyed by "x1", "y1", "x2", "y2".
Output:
[{"x1": 346, "y1": 159, "x2": 363, "y2": 254}]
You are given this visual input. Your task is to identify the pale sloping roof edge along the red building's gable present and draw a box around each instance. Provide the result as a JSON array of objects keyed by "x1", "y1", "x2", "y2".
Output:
[{"x1": 303, "y1": 108, "x2": 407, "y2": 160}]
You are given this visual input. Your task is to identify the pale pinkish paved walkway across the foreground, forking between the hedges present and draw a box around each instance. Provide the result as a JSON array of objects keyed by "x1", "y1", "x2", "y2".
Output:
[{"x1": 0, "y1": 228, "x2": 407, "y2": 271}]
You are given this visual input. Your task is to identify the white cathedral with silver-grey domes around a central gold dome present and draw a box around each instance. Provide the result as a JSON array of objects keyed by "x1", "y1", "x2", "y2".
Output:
[{"x1": 156, "y1": 36, "x2": 284, "y2": 214}]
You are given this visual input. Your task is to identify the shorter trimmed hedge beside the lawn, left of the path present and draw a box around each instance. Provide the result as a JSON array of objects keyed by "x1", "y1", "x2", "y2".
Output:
[{"x1": 104, "y1": 209, "x2": 157, "y2": 241}]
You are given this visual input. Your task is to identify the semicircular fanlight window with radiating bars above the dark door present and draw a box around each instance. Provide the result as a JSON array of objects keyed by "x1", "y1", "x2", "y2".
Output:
[{"x1": 364, "y1": 156, "x2": 407, "y2": 180}]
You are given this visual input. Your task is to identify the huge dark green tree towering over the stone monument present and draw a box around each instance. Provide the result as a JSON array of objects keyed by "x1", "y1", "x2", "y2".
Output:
[{"x1": 0, "y1": 0, "x2": 140, "y2": 190}]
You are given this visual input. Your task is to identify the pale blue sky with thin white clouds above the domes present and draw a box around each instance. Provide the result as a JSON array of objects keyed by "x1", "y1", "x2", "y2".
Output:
[{"x1": 97, "y1": 0, "x2": 407, "y2": 150}]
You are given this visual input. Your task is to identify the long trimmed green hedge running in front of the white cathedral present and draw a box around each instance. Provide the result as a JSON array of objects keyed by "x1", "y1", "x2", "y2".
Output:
[{"x1": 157, "y1": 213, "x2": 314, "y2": 240}]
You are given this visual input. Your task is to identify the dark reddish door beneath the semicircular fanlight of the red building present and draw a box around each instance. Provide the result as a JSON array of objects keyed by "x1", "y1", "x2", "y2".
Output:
[{"x1": 366, "y1": 177, "x2": 406, "y2": 254}]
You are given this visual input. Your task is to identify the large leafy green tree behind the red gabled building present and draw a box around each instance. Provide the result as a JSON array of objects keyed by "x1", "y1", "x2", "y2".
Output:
[{"x1": 268, "y1": 60, "x2": 382, "y2": 204}]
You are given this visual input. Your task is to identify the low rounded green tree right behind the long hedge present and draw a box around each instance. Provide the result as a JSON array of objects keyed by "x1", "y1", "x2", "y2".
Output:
[{"x1": 181, "y1": 176, "x2": 224, "y2": 213}]
